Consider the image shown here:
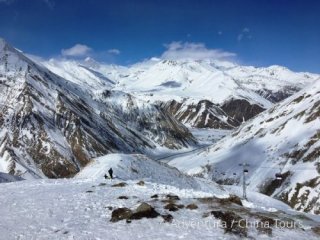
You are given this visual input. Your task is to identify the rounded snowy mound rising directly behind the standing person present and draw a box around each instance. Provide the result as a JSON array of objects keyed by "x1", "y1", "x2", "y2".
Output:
[{"x1": 75, "y1": 154, "x2": 228, "y2": 193}]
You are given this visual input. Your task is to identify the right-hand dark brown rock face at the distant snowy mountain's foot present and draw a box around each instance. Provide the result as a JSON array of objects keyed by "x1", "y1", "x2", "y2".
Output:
[{"x1": 221, "y1": 99, "x2": 265, "y2": 123}]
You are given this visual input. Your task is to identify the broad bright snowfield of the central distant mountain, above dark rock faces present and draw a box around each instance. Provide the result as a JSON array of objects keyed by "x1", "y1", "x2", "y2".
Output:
[{"x1": 115, "y1": 60, "x2": 319, "y2": 104}]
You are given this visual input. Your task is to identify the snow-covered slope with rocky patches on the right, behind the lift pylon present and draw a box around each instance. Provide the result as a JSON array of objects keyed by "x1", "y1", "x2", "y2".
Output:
[{"x1": 169, "y1": 80, "x2": 320, "y2": 214}]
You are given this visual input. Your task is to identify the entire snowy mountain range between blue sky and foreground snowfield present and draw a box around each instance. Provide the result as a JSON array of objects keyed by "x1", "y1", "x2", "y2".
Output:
[{"x1": 0, "y1": 39, "x2": 320, "y2": 214}]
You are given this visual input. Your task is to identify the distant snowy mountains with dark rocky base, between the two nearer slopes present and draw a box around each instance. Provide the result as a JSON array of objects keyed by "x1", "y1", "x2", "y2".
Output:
[{"x1": 43, "y1": 58, "x2": 319, "y2": 129}]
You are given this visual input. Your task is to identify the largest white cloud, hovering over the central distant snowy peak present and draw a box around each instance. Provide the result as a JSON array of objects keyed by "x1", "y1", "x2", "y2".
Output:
[{"x1": 161, "y1": 42, "x2": 236, "y2": 60}]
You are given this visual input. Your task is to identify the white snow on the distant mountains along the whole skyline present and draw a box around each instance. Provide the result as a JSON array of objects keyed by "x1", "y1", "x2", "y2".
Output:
[{"x1": 38, "y1": 58, "x2": 319, "y2": 113}]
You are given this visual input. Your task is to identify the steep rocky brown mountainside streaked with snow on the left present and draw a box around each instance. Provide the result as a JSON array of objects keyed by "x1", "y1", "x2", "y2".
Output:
[{"x1": 0, "y1": 39, "x2": 195, "y2": 178}]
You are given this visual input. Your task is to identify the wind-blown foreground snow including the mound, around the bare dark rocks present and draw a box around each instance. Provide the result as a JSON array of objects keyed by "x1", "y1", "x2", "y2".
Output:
[{"x1": 0, "y1": 155, "x2": 320, "y2": 240}]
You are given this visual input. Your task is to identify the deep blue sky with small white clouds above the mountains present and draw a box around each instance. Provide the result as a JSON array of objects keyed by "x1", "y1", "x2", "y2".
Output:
[{"x1": 0, "y1": 0, "x2": 320, "y2": 73}]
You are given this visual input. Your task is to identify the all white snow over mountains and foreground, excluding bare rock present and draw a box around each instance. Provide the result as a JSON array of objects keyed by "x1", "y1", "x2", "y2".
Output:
[{"x1": 0, "y1": 39, "x2": 320, "y2": 240}]
